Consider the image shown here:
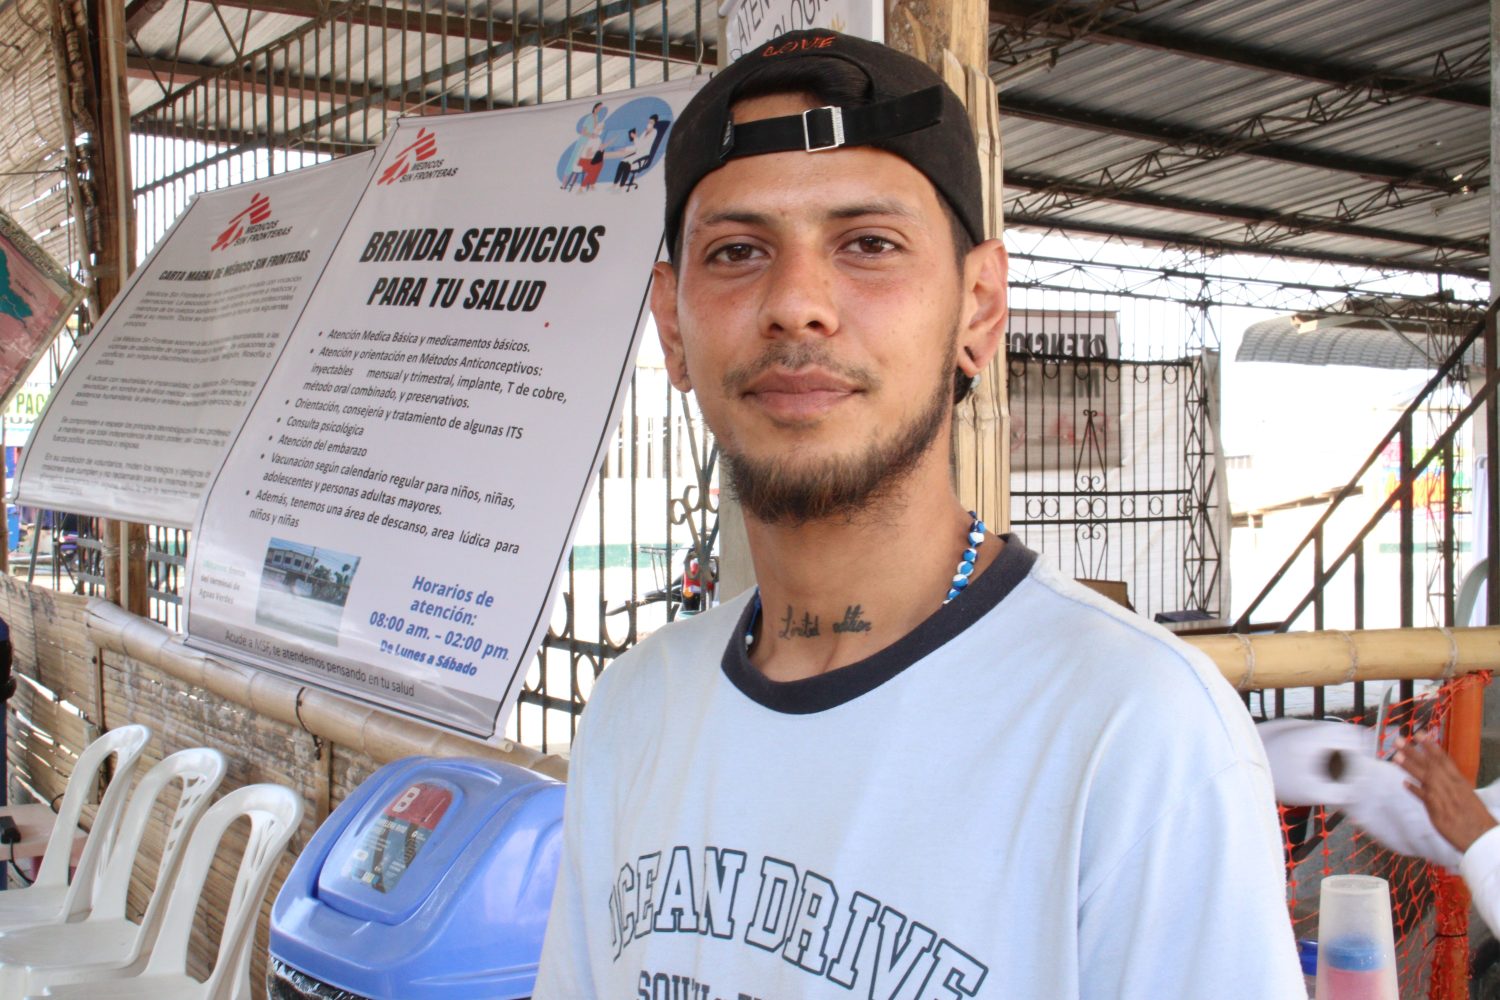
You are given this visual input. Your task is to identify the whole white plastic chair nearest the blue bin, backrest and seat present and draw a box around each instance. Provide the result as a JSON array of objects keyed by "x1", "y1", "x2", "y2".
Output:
[{"x1": 21, "y1": 784, "x2": 303, "y2": 1000}]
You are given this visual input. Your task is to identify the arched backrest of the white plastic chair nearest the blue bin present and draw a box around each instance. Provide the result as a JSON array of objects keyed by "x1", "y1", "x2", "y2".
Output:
[{"x1": 143, "y1": 784, "x2": 303, "y2": 997}]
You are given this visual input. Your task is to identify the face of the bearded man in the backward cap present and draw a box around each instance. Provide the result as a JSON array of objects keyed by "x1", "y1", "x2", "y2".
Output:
[{"x1": 653, "y1": 94, "x2": 1004, "y2": 522}]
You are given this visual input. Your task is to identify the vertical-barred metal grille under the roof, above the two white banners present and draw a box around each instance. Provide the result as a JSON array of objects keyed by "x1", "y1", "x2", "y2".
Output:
[{"x1": 131, "y1": 0, "x2": 713, "y2": 250}]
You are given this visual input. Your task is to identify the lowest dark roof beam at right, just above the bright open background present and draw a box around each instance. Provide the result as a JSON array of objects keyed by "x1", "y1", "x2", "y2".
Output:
[{"x1": 1005, "y1": 169, "x2": 1488, "y2": 253}]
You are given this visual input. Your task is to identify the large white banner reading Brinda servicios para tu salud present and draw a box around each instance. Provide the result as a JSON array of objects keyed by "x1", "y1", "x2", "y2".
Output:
[{"x1": 188, "y1": 81, "x2": 698, "y2": 738}]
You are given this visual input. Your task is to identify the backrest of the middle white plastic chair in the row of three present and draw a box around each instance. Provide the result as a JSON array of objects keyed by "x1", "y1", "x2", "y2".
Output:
[{"x1": 84, "y1": 747, "x2": 224, "y2": 949}]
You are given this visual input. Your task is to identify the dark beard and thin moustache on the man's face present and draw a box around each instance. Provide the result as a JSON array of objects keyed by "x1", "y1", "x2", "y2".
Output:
[{"x1": 723, "y1": 331, "x2": 957, "y2": 526}]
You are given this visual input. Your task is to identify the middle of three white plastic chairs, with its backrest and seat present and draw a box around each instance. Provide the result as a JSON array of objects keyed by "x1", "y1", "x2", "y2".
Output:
[{"x1": 0, "y1": 748, "x2": 224, "y2": 997}]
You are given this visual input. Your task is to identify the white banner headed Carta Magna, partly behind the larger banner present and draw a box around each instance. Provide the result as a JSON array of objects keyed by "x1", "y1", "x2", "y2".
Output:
[{"x1": 17, "y1": 153, "x2": 372, "y2": 528}]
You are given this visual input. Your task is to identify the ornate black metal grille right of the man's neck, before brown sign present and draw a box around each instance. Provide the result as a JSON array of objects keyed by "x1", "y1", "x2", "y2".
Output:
[{"x1": 1010, "y1": 355, "x2": 1221, "y2": 618}]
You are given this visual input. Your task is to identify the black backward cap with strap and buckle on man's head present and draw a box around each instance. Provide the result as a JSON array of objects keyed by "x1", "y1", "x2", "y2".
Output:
[{"x1": 666, "y1": 28, "x2": 986, "y2": 257}]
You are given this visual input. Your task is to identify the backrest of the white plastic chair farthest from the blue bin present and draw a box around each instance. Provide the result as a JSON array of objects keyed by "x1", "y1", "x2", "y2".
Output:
[{"x1": 33, "y1": 724, "x2": 152, "y2": 916}]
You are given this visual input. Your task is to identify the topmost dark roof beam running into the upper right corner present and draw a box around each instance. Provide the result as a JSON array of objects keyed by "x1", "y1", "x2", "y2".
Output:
[{"x1": 990, "y1": 0, "x2": 1490, "y2": 108}]
